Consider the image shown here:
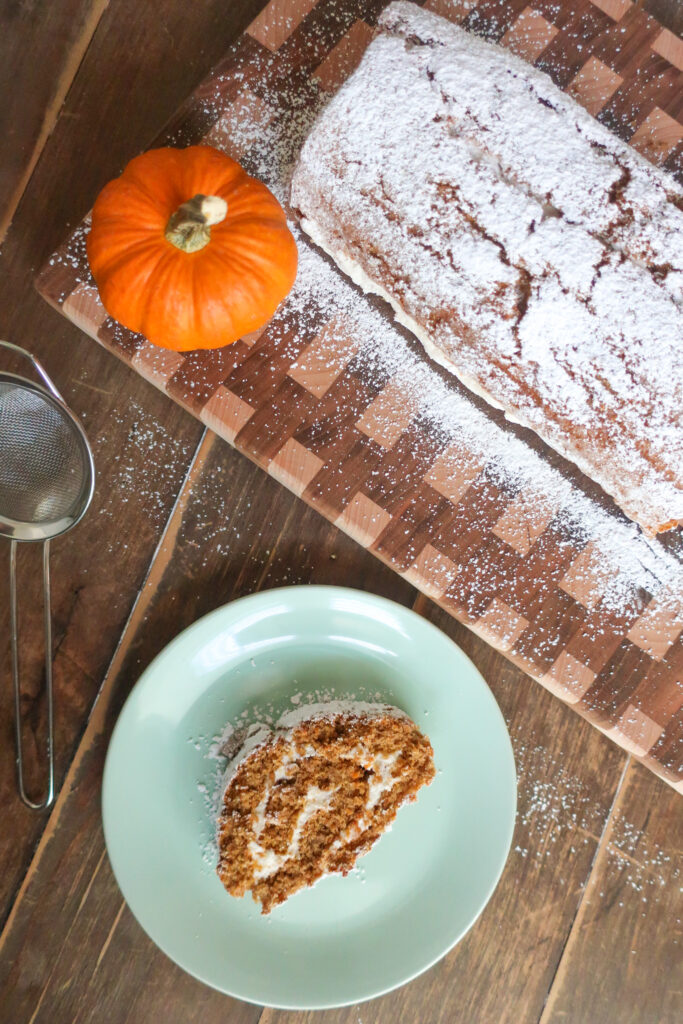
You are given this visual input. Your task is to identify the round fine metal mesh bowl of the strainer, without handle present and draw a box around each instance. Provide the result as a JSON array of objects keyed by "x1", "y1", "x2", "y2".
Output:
[{"x1": 0, "y1": 381, "x2": 87, "y2": 523}]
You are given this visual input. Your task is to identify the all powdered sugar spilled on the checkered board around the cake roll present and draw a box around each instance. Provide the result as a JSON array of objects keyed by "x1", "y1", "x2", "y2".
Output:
[{"x1": 48, "y1": 4, "x2": 683, "y2": 613}]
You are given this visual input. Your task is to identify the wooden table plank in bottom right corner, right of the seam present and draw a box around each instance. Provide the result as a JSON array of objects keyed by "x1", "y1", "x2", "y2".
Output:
[{"x1": 540, "y1": 763, "x2": 683, "y2": 1024}]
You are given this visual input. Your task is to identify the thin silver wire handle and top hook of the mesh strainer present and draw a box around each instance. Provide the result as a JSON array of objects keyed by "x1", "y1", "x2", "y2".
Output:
[{"x1": 0, "y1": 340, "x2": 63, "y2": 811}]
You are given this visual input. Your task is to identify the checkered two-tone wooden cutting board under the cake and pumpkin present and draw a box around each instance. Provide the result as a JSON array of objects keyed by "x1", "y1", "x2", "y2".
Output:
[{"x1": 38, "y1": 0, "x2": 683, "y2": 792}]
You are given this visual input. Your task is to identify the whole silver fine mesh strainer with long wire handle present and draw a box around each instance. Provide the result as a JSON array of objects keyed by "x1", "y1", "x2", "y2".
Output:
[{"x1": 0, "y1": 341, "x2": 95, "y2": 810}]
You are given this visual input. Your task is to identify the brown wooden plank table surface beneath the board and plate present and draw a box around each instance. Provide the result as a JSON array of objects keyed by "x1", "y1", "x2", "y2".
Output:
[{"x1": 0, "y1": 0, "x2": 683, "y2": 1024}]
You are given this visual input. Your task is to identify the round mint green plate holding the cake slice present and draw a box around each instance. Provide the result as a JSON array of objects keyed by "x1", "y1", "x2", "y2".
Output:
[{"x1": 102, "y1": 587, "x2": 515, "y2": 1009}]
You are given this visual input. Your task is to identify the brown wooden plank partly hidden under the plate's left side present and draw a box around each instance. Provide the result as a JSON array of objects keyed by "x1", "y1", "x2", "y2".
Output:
[{"x1": 0, "y1": 436, "x2": 415, "y2": 1024}]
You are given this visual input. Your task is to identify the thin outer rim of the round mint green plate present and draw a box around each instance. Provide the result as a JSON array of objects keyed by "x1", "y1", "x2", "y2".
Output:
[{"x1": 100, "y1": 584, "x2": 518, "y2": 1011}]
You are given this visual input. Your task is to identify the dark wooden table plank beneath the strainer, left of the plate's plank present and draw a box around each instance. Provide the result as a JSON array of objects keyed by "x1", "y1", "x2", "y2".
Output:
[{"x1": 0, "y1": 0, "x2": 270, "y2": 922}]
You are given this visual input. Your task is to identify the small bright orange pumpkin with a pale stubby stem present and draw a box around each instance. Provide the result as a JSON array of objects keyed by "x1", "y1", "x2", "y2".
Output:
[{"x1": 87, "y1": 145, "x2": 297, "y2": 351}]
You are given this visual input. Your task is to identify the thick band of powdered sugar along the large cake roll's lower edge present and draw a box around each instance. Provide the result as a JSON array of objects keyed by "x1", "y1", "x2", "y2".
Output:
[{"x1": 290, "y1": 238, "x2": 683, "y2": 611}]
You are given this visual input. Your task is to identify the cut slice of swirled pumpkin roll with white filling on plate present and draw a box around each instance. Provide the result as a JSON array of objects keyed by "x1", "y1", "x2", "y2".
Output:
[{"x1": 217, "y1": 700, "x2": 434, "y2": 913}]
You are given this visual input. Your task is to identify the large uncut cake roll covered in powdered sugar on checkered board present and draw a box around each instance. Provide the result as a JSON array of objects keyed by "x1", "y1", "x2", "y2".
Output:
[{"x1": 292, "y1": 2, "x2": 683, "y2": 534}]
